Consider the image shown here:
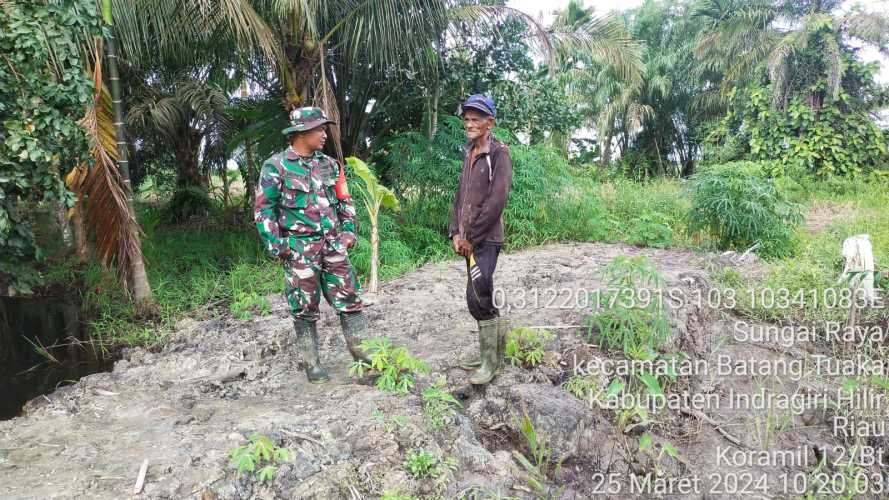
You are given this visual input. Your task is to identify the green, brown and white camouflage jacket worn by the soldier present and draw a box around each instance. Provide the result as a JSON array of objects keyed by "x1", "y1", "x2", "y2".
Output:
[{"x1": 254, "y1": 148, "x2": 357, "y2": 257}]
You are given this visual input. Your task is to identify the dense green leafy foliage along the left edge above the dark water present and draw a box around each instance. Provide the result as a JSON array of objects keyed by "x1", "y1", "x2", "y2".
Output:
[{"x1": 0, "y1": 0, "x2": 99, "y2": 292}]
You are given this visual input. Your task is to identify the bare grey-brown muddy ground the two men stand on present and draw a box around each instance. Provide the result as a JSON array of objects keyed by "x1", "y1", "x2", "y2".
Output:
[{"x1": 0, "y1": 244, "x2": 876, "y2": 499}]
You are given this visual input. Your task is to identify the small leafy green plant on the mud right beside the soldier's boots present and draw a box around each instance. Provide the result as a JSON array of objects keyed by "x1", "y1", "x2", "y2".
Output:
[{"x1": 349, "y1": 337, "x2": 429, "y2": 394}]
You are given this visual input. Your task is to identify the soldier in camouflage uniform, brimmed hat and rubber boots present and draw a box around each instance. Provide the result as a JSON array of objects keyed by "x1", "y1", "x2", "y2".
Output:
[{"x1": 254, "y1": 107, "x2": 370, "y2": 383}]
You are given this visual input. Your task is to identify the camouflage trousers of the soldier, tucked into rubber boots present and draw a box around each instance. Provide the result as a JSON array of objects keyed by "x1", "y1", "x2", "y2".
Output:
[{"x1": 284, "y1": 237, "x2": 363, "y2": 321}]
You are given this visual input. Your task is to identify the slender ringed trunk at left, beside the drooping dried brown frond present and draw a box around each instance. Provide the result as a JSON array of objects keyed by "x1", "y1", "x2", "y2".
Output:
[{"x1": 102, "y1": 0, "x2": 153, "y2": 303}]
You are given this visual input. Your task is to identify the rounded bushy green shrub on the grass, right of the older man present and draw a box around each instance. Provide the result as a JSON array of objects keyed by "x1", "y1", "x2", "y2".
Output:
[{"x1": 687, "y1": 162, "x2": 803, "y2": 257}]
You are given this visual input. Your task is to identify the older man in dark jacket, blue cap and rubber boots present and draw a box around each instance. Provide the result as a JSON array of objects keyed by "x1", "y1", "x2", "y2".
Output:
[{"x1": 448, "y1": 94, "x2": 512, "y2": 384}]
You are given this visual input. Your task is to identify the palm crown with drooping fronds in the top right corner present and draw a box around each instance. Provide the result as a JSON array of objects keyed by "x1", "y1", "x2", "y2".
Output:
[{"x1": 694, "y1": 0, "x2": 889, "y2": 109}]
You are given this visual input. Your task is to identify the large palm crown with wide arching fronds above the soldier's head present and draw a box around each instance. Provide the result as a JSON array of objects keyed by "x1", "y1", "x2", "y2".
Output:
[{"x1": 111, "y1": 0, "x2": 641, "y2": 158}]
